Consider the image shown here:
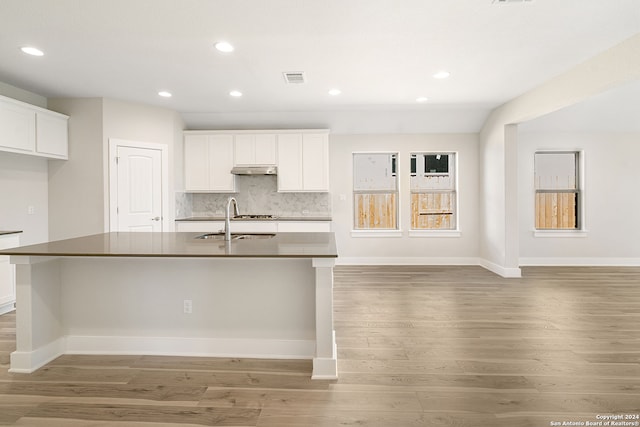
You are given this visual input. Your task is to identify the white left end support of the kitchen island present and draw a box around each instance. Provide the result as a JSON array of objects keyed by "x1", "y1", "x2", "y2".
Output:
[{"x1": 9, "y1": 256, "x2": 65, "y2": 373}]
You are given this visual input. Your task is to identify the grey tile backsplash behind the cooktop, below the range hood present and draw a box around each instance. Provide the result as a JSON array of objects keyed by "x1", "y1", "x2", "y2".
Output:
[{"x1": 176, "y1": 175, "x2": 331, "y2": 218}]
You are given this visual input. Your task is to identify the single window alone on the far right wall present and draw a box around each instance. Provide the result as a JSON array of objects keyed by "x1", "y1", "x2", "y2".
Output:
[{"x1": 534, "y1": 152, "x2": 580, "y2": 230}]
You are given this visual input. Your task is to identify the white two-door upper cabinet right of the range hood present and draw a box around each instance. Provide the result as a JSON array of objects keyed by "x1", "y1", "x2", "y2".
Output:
[{"x1": 278, "y1": 133, "x2": 329, "y2": 192}]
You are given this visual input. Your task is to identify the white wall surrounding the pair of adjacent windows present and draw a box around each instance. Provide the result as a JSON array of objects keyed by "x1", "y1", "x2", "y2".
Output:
[{"x1": 329, "y1": 134, "x2": 479, "y2": 264}]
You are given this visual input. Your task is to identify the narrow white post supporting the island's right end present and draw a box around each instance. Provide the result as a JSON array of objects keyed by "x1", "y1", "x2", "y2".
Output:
[{"x1": 312, "y1": 258, "x2": 338, "y2": 379}]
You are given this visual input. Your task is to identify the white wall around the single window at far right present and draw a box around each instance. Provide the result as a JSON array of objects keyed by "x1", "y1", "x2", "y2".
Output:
[{"x1": 518, "y1": 132, "x2": 640, "y2": 265}]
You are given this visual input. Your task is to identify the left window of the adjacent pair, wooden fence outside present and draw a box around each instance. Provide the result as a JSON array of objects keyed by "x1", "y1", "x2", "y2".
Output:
[{"x1": 353, "y1": 153, "x2": 398, "y2": 230}]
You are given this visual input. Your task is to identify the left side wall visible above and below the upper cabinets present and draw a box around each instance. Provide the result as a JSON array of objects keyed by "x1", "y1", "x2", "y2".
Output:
[{"x1": 0, "y1": 82, "x2": 48, "y2": 244}]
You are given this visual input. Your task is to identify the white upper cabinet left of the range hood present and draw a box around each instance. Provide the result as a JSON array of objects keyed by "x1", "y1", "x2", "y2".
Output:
[{"x1": 184, "y1": 134, "x2": 235, "y2": 193}]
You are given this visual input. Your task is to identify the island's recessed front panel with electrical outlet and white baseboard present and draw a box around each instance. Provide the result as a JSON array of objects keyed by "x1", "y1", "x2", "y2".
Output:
[{"x1": 62, "y1": 258, "x2": 316, "y2": 358}]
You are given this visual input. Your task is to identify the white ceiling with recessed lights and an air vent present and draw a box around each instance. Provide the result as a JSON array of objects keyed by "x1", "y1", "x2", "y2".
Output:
[{"x1": 0, "y1": 0, "x2": 640, "y2": 132}]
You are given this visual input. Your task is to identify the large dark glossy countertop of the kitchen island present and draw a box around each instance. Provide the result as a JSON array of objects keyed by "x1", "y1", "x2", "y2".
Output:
[{"x1": 0, "y1": 232, "x2": 338, "y2": 258}]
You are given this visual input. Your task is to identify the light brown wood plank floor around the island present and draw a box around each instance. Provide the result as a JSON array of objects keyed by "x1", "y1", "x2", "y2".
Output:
[{"x1": 0, "y1": 267, "x2": 640, "y2": 427}]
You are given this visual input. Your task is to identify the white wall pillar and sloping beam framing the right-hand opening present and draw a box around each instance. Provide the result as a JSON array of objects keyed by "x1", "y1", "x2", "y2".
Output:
[{"x1": 480, "y1": 34, "x2": 640, "y2": 277}]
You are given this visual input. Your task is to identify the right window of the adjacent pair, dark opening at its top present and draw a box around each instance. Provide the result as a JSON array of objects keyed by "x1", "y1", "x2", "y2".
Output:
[{"x1": 411, "y1": 153, "x2": 457, "y2": 230}]
